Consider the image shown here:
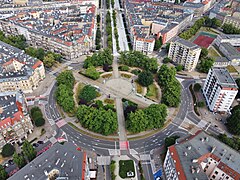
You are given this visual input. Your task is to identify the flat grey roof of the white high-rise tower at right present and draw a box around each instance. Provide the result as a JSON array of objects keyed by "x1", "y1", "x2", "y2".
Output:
[{"x1": 212, "y1": 67, "x2": 238, "y2": 88}]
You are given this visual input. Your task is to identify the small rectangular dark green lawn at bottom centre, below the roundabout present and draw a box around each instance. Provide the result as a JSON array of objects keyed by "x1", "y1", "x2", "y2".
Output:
[{"x1": 119, "y1": 160, "x2": 135, "y2": 178}]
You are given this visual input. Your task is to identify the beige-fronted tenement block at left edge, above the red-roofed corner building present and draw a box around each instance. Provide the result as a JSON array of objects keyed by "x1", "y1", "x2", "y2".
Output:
[{"x1": 0, "y1": 41, "x2": 45, "y2": 93}]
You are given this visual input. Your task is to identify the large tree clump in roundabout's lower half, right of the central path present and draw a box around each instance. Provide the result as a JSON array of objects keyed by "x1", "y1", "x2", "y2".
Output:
[{"x1": 126, "y1": 104, "x2": 167, "y2": 133}]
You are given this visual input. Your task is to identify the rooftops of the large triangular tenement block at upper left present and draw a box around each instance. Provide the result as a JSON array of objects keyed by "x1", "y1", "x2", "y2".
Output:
[{"x1": 1, "y1": 4, "x2": 96, "y2": 46}]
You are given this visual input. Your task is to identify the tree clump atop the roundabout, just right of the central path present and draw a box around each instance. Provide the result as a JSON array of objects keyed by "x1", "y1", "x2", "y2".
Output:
[{"x1": 119, "y1": 51, "x2": 158, "y2": 72}]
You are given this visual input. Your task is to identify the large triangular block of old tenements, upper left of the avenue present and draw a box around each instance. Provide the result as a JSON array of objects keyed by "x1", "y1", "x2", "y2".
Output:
[{"x1": 0, "y1": 4, "x2": 96, "y2": 60}]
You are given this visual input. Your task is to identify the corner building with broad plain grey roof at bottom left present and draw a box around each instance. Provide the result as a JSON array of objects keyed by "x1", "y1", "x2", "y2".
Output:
[{"x1": 9, "y1": 142, "x2": 90, "y2": 180}]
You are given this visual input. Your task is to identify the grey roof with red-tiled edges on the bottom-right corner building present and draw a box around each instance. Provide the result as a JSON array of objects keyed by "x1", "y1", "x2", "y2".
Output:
[{"x1": 169, "y1": 131, "x2": 240, "y2": 179}]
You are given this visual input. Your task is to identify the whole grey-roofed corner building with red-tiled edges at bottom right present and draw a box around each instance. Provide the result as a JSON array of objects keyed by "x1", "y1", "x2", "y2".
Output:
[{"x1": 164, "y1": 131, "x2": 240, "y2": 180}]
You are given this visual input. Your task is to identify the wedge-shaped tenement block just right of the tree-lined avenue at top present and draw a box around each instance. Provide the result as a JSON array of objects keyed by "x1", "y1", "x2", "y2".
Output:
[{"x1": 124, "y1": 0, "x2": 193, "y2": 53}]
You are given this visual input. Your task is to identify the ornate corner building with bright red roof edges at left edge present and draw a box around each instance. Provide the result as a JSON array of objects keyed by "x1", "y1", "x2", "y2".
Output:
[{"x1": 0, "y1": 91, "x2": 33, "y2": 149}]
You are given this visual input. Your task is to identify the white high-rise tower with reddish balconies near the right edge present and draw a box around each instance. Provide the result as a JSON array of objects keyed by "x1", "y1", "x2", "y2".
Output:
[{"x1": 202, "y1": 67, "x2": 238, "y2": 112}]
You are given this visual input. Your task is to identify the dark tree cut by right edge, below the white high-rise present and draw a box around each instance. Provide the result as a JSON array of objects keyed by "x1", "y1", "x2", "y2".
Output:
[{"x1": 227, "y1": 105, "x2": 240, "y2": 135}]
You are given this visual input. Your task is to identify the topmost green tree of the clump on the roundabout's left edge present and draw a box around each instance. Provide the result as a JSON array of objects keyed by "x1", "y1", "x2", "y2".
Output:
[{"x1": 57, "y1": 70, "x2": 75, "y2": 89}]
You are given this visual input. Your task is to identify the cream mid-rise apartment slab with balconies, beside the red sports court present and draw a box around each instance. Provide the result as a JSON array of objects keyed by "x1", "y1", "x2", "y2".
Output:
[{"x1": 168, "y1": 38, "x2": 201, "y2": 71}]
